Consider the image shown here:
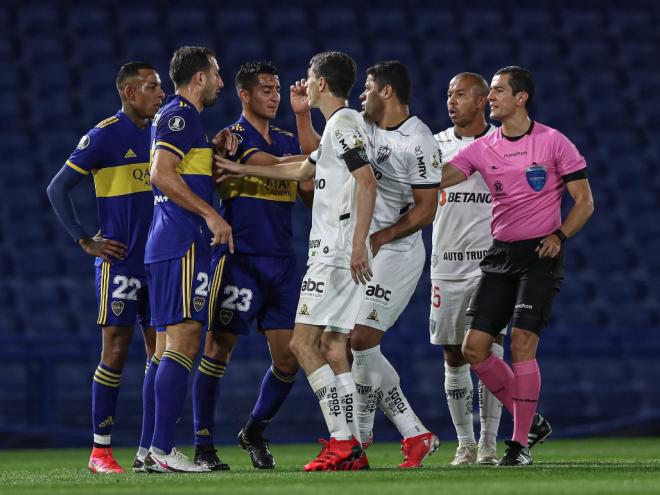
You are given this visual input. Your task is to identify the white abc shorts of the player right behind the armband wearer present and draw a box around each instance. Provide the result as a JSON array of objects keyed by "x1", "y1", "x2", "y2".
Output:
[{"x1": 356, "y1": 239, "x2": 426, "y2": 332}]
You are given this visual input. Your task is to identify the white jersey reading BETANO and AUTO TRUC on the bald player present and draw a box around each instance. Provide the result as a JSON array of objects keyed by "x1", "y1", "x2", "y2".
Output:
[{"x1": 431, "y1": 125, "x2": 496, "y2": 280}]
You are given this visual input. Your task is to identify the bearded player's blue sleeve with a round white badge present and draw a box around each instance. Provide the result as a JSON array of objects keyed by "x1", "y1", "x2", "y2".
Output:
[{"x1": 154, "y1": 106, "x2": 199, "y2": 160}]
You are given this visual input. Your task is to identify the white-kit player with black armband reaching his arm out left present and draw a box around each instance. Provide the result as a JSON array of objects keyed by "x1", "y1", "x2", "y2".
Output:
[{"x1": 215, "y1": 52, "x2": 376, "y2": 471}]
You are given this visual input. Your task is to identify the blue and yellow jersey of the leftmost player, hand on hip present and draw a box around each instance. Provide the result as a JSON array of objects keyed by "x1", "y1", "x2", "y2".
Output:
[{"x1": 66, "y1": 112, "x2": 153, "y2": 275}]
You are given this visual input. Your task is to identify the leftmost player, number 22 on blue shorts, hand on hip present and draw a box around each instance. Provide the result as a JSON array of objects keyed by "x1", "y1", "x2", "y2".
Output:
[{"x1": 48, "y1": 62, "x2": 165, "y2": 473}]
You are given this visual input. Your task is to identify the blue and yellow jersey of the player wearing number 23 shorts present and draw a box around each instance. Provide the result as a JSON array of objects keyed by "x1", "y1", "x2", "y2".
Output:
[{"x1": 214, "y1": 115, "x2": 300, "y2": 256}]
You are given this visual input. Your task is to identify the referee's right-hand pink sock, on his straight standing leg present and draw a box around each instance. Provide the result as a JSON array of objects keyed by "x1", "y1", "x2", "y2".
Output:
[{"x1": 513, "y1": 359, "x2": 541, "y2": 446}]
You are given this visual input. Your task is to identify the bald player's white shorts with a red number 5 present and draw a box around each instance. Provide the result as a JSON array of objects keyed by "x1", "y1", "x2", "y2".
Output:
[{"x1": 429, "y1": 275, "x2": 506, "y2": 345}]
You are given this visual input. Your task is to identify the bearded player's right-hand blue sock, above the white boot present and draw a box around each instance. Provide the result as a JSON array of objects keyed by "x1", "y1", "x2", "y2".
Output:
[{"x1": 151, "y1": 351, "x2": 192, "y2": 454}]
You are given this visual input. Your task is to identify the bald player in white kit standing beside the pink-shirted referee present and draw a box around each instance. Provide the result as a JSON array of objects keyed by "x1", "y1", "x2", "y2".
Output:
[{"x1": 429, "y1": 72, "x2": 506, "y2": 466}]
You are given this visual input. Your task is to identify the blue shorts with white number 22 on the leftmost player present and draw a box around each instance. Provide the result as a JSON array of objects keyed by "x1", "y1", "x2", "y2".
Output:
[{"x1": 96, "y1": 261, "x2": 151, "y2": 330}]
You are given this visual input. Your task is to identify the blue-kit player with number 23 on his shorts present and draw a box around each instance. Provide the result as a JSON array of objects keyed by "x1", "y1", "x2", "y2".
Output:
[{"x1": 193, "y1": 62, "x2": 314, "y2": 471}]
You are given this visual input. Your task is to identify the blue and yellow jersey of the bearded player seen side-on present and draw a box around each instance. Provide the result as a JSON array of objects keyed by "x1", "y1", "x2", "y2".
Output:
[{"x1": 144, "y1": 95, "x2": 213, "y2": 263}]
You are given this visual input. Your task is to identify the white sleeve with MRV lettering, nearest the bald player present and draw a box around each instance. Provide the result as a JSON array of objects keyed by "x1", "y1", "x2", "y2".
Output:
[{"x1": 406, "y1": 132, "x2": 442, "y2": 189}]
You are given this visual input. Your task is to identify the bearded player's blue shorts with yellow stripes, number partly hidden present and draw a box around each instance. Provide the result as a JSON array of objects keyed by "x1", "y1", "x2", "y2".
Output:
[{"x1": 145, "y1": 243, "x2": 211, "y2": 330}]
